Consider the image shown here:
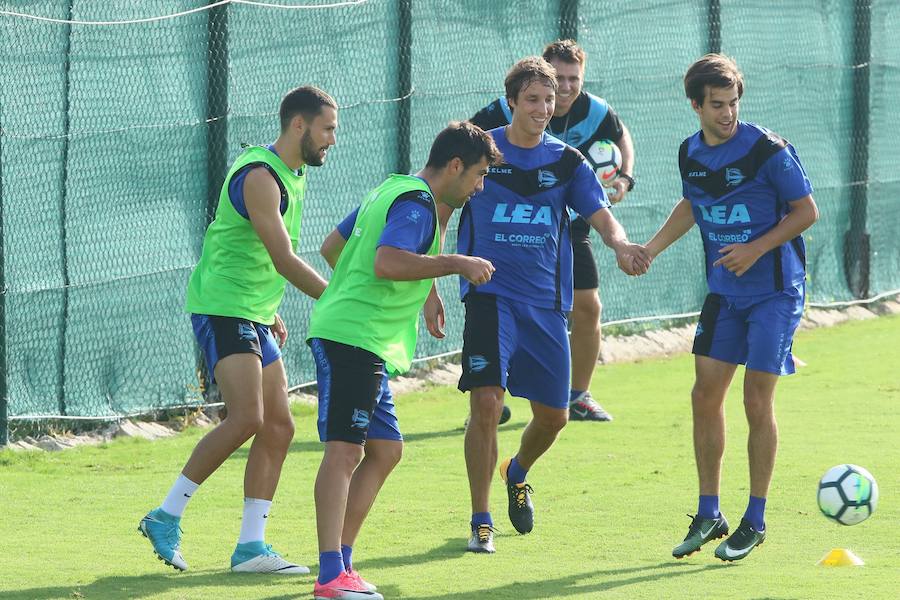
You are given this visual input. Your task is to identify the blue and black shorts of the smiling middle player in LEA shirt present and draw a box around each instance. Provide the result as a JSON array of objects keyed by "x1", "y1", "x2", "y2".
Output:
[{"x1": 459, "y1": 294, "x2": 571, "y2": 408}]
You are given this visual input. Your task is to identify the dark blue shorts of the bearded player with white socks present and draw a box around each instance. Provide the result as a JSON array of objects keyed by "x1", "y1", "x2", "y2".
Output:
[{"x1": 191, "y1": 315, "x2": 281, "y2": 381}]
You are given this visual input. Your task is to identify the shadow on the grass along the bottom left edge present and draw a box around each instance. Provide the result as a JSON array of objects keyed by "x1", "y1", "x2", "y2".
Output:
[{"x1": 0, "y1": 570, "x2": 315, "y2": 600}]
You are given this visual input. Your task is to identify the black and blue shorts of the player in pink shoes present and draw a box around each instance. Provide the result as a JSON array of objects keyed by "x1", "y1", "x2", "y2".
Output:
[{"x1": 309, "y1": 338, "x2": 403, "y2": 445}]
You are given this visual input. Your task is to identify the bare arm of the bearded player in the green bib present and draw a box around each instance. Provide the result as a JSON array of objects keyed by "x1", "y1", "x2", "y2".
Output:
[{"x1": 244, "y1": 168, "x2": 327, "y2": 299}]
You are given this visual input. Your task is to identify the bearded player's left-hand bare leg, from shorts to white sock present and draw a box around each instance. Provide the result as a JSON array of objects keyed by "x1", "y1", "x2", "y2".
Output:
[{"x1": 182, "y1": 354, "x2": 263, "y2": 484}]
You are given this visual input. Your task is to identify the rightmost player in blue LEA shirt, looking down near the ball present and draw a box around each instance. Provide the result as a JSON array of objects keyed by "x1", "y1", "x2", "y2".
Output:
[{"x1": 647, "y1": 54, "x2": 818, "y2": 561}]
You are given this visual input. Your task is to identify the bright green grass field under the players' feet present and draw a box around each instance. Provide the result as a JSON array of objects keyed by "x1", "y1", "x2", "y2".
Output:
[{"x1": 0, "y1": 317, "x2": 900, "y2": 600}]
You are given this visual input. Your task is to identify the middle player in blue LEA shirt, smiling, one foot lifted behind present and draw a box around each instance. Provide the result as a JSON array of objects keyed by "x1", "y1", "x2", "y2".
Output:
[{"x1": 458, "y1": 56, "x2": 649, "y2": 552}]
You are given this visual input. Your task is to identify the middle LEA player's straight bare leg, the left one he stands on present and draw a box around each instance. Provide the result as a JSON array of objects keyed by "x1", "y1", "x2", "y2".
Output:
[{"x1": 465, "y1": 386, "x2": 504, "y2": 513}]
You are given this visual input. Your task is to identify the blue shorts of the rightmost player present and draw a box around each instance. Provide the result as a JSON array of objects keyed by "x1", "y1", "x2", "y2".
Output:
[{"x1": 693, "y1": 283, "x2": 805, "y2": 375}]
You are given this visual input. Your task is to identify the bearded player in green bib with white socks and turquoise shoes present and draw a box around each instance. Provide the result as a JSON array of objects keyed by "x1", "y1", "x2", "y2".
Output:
[{"x1": 138, "y1": 87, "x2": 337, "y2": 575}]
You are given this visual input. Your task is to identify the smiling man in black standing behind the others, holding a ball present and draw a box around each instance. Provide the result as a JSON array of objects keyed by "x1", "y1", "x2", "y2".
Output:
[{"x1": 470, "y1": 40, "x2": 634, "y2": 421}]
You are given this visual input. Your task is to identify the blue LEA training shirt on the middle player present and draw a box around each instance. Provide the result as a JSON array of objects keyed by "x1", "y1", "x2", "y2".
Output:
[{"x1": 457, "y1": 127, "x2": 609, "y2": 311}]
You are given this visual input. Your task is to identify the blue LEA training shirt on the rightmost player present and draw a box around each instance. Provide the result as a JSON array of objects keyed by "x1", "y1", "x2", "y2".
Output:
[{"x1": 678, "y1": 121, "x2": 812, "y2": 296}]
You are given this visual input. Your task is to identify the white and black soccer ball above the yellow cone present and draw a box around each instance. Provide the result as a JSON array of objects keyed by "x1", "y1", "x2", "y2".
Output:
[{"x1": 818, "y1": 465, "x2": 878, "y2": 525}]
